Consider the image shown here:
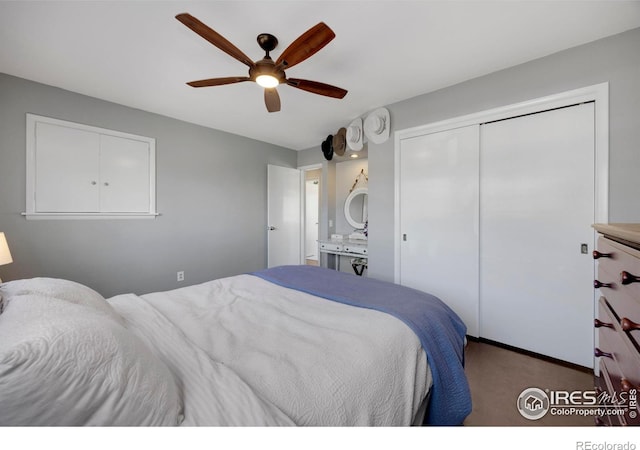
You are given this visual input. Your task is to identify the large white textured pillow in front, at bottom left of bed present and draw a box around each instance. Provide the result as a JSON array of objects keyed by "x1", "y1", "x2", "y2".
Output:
[{"x1": 0, "y1": 294, "x2": 183, "y2": 426}]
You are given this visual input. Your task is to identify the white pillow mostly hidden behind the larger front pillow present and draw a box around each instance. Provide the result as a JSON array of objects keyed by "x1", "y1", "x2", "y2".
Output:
[{"x1": 0, "y1": 278, "x2": 125, "y2": 325}]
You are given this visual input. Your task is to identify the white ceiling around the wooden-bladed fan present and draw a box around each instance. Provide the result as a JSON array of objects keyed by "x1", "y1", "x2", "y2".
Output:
[{"x1": 0, "y1": 0, "x2": 640, "y2": 150}]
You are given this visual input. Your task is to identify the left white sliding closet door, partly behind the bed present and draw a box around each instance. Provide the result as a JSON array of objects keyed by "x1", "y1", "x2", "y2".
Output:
[{"x1": 399, "y1": 125, "x2": 479, "y2": 336}]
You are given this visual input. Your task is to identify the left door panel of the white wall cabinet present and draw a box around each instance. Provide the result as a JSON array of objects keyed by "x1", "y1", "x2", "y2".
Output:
[{"x1": 35, "y1": 123, "x2": 100, "y2": 212}]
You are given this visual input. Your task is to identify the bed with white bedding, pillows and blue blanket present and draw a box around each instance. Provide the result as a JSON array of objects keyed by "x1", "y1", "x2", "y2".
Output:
[{"x1": 0, "y1": 266, "x2": 471, "y2": 426}]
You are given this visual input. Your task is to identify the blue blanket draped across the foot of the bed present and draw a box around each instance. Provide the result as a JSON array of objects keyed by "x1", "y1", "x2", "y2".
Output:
[{"x1": 252, "y1": 266, "x2": 471, "y2": 425}]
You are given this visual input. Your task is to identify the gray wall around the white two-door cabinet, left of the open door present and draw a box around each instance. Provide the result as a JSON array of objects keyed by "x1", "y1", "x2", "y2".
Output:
[{"x1": 0, "y1": 74, "x2": 297, "y2": 296}]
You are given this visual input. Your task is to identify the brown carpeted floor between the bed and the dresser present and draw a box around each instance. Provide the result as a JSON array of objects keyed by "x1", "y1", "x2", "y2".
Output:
[{"x1": 464, "y1": 341, "x2": 594, "y2": 426}]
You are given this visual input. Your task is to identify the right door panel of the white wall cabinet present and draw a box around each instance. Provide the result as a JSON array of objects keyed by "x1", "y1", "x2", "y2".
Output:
[{"x1": 100, "y1": 135, "x2": 150, "y2": 213}]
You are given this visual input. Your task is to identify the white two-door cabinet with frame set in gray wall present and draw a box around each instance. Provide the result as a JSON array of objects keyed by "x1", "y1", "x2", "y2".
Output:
[{"x1": 25, "y1": 114, "x2": 156, "y2": 218}]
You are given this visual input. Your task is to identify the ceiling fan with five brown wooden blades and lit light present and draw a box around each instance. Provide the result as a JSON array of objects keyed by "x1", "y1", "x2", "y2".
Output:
[{"x1": 176, "y1": 13, "x2": 347, "y2": 112}]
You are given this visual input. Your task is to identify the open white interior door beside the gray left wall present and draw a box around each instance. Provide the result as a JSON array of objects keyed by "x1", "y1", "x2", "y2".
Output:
[{"x1": 267, "y1": 165, "x2": 302, "y2": 267}]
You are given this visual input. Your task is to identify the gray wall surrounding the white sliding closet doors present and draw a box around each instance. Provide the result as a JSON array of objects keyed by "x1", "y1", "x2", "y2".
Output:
[{"x1": 298, "y1": 28, "x2": 640, "y2": 281}]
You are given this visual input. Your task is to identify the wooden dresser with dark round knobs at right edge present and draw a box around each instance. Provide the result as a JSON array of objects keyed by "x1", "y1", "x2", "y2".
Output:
[{"x1": 593, "y1": 224, "x2": 640, "y2": 425}]
